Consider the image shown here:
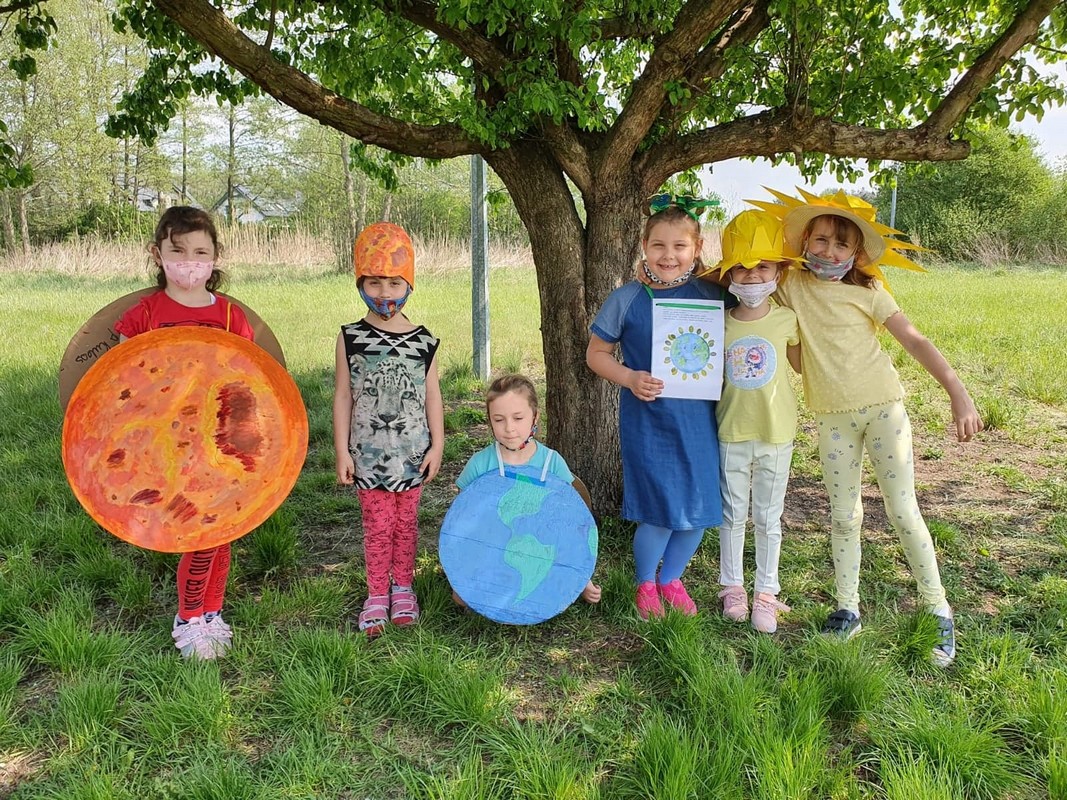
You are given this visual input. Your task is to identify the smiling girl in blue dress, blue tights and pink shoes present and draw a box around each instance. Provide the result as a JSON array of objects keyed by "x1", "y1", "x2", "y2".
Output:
[{"x1": 586, "y1": 195, "x2": 724, "y2": 620}]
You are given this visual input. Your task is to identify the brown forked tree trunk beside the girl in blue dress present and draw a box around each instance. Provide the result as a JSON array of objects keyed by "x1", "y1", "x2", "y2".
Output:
[{"x1": 485, "y1": 144, "x2": 644, "y2": 515}]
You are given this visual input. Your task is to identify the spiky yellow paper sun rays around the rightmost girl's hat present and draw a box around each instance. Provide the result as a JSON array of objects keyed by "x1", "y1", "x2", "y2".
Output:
[{"x1": 746, "y1": 187, "x2": 926, "y2": 286}]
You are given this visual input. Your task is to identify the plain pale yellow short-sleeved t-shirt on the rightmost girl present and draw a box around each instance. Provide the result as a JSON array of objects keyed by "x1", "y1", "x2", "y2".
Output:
[{"x1": 775, "y1": 270, "x2": 904, "y2": 414}]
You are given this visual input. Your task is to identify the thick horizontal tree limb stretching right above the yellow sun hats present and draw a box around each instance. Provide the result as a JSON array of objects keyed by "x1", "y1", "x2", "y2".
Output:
[{"x1": 637, "y1": 109, "x2": 971, "y2": 186}]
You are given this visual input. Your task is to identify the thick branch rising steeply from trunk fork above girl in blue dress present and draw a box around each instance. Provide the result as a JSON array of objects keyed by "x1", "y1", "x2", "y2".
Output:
[{"x1": 598, "y1": 0, "x2": 746, "y2": 174}]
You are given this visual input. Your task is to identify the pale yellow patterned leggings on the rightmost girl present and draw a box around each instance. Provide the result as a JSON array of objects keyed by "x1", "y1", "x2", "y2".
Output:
[{"x1": 815, "y1": 400, "x2": 951, "y2": 615}]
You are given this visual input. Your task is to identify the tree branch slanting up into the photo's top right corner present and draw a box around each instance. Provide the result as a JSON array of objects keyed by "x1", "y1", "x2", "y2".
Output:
[{"x1": 920, "y1": 0, "x2": 1063, "y2": 137}]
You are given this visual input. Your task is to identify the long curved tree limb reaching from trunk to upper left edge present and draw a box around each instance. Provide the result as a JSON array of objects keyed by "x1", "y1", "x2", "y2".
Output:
[{"x1": 153, "y1": 0, "x2": 484, "y2": 158}]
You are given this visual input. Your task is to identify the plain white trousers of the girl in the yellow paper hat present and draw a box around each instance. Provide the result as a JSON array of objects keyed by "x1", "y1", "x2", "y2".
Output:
[{"x1": 719, "y1": 442, "x2": 793, "y2": 595}]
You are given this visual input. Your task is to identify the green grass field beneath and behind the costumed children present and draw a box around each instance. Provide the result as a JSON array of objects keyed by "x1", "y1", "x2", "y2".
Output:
[{"x1": 0, "y1": 268, "x2": 1067, "y2": 800}]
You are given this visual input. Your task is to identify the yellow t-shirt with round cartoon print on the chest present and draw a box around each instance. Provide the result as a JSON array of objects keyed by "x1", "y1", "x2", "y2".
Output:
[{"x1": 715, "y1": 305, "x2": 800, "y2": 445}]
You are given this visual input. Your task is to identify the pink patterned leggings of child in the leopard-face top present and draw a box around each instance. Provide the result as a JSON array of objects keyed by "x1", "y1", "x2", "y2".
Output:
[{"x1": 356, "y1": 486, "x2": 423, "y2": 595}]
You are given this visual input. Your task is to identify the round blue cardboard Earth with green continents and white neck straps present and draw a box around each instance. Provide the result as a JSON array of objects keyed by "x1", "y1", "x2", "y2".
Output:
[{"x1": 439, "y1": 445, "x2": 598, "y2": 625}]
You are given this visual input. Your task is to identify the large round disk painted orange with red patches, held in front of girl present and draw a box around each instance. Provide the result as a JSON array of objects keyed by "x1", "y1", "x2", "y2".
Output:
[{"x1": 63, "y1": 326, "x2": 307, "y2": 553}]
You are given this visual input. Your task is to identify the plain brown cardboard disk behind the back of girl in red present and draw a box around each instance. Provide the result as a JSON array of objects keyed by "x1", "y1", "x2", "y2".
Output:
[{"x1": 60, "y1": 287, "x2": 285, "y2": 409}]
